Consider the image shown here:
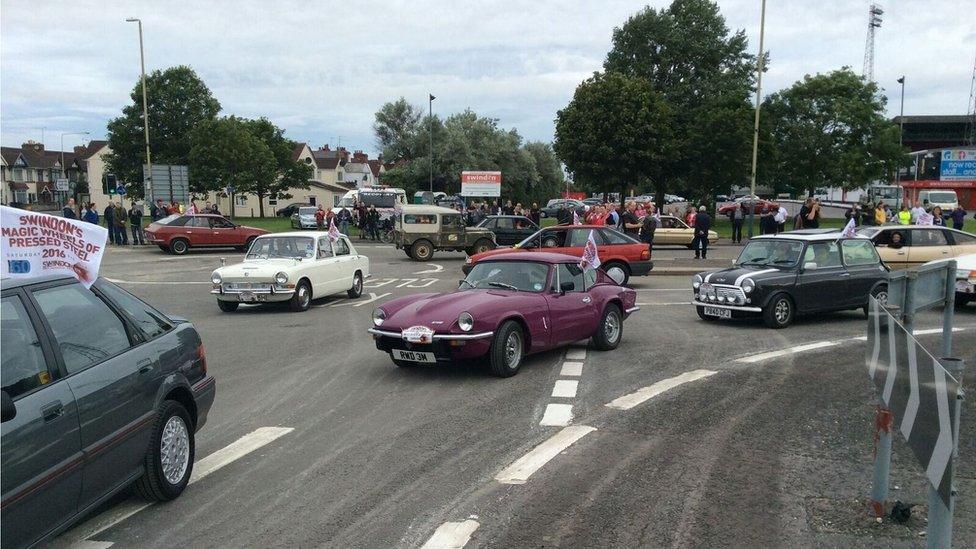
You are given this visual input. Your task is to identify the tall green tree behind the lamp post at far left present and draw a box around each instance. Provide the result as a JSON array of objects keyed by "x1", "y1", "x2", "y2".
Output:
[{"x1": 107, "y1": 65, "x2": 220, "y2": 196}]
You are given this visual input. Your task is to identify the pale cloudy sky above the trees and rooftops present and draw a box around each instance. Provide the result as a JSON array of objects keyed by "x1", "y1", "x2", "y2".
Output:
[{"x1": 0, "y1": 0, "x2": 976, "y2": 153}]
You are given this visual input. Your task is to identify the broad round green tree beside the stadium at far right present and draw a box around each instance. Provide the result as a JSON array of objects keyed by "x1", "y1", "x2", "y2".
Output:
[{"x1": 762, "y1": 67, "x2": 905, "y2": 195}]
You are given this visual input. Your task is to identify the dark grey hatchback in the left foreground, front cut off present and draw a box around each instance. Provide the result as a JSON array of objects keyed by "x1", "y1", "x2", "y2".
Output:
[{"x1": 0, "y1": 277, "x2": 216, "y2": 548}]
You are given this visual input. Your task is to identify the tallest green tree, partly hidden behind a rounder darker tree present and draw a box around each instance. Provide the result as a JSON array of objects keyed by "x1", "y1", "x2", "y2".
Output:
[{"x1": 604, "y1": 0, "x2": 755, "y2": 205}]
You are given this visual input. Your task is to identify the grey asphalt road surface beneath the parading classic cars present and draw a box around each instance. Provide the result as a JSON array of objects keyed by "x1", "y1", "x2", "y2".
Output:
[{"x1": 43, "y1": 241, "x2": 976, "y2": 548}]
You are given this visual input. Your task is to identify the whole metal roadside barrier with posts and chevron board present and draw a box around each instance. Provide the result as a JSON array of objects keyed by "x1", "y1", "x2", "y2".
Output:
[{"x1": 865, "y1": 260, "x2": 964, "y2": 547}]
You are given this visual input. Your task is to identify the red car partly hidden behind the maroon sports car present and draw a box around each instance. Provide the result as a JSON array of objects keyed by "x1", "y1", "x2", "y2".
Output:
[{"x1": 461, "y1": 225, "x2": 654, "y2": 286}]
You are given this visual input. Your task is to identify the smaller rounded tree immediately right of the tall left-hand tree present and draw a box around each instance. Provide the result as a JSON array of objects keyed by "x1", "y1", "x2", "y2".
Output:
[{"x1": 189, "y1": 116, "x2": 278, "y2": 217}]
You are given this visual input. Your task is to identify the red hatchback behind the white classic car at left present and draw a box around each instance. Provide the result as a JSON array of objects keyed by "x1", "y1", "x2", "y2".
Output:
[{"x1": 146, "y1": 214, "x2": 268, "y2": 255}]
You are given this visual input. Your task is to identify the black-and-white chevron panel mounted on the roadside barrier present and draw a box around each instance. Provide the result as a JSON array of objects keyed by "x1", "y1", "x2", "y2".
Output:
[{"x1": 865, "y1": 297, "x2": 959, "y2": 505}]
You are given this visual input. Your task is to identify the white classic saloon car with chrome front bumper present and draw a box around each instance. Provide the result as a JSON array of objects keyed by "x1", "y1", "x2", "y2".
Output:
[{"x1": 210, "y1": 231, "x2": 369, "y2": 312}]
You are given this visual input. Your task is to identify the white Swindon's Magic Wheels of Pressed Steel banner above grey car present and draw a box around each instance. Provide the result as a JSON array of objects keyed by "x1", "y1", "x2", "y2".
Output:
[{"x1": 0, "y1": 206, "x2": 108, "y2": 288}]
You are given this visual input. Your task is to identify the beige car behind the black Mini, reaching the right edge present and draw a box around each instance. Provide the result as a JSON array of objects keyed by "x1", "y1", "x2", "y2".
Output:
[{"x1": 858, "y1": 225, "x2": 976, "y2": 269}]
